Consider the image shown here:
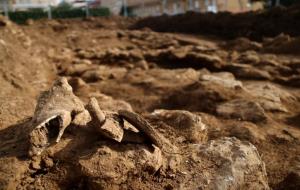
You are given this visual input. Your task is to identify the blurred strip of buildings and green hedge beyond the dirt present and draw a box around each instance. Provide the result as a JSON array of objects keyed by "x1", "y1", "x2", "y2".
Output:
[{"x1": 0, "y1": 0, "x2": 298, "y2": 17}]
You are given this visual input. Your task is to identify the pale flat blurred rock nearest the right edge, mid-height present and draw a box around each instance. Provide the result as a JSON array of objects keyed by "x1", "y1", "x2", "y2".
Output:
[{"x1": 245, "y1": 83, "x2": 296, "y2": 112}]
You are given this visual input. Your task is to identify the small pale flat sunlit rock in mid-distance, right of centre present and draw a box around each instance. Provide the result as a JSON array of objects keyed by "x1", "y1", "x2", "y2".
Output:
[{"x1": 200, "y1": 72, "x2": 243, "y2": 88}]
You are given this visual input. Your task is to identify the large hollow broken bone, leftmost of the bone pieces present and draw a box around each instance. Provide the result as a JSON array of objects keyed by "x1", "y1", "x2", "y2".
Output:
[{"x1": 29, "y1": 77, "x2": 91, "y2": 156}]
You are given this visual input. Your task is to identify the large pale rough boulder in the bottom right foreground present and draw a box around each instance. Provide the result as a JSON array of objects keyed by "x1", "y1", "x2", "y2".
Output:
[{"x1": 195, "y1": 137, "x2": 269, "y2": 190}]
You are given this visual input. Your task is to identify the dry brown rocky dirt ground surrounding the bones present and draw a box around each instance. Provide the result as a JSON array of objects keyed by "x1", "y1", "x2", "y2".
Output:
[{"x1": 0, "y1": 13, "x2": 300, "y2": 189}]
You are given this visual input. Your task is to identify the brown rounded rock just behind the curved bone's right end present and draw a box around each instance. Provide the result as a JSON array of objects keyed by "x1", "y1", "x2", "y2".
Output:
[{"x1": 151, "y1": 110, "x2": 207, "y2": 143}]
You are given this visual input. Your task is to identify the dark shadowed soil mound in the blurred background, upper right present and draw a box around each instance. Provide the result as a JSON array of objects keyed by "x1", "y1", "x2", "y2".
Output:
[{"x1": 132, "y1": 5, "x2": 300, "y2": 40}]
